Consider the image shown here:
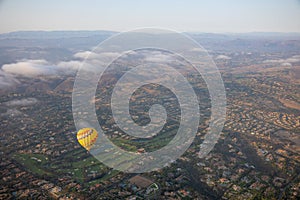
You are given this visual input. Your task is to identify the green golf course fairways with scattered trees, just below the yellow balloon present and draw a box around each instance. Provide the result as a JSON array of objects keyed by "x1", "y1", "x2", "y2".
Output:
[{"x1": 13, "y1": 150, "x2": 119, "y2": 185}]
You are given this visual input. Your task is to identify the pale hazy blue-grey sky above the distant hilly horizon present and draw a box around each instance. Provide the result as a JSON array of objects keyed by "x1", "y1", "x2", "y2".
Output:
[{"x1": 0, "y1": 0, "x2": 300, "y2": 33}]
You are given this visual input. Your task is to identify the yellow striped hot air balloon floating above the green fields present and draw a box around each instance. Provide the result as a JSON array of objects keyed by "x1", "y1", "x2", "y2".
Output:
[{"x1": 77, "y1": 128, "x2": 98, "y2": 151}]
